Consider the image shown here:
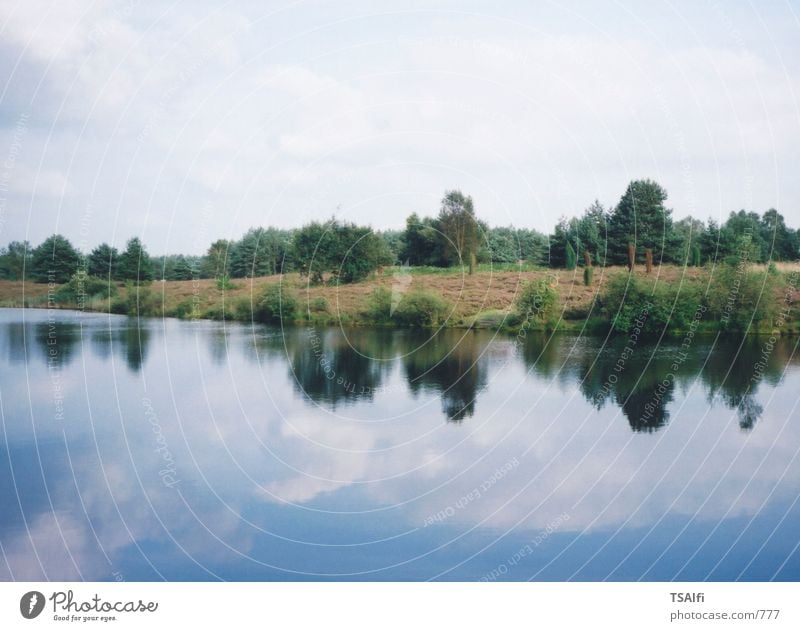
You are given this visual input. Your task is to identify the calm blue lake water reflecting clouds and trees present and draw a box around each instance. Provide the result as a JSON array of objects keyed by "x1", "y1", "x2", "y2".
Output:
[{"x1": 0, "y1": 309, "x2": 800, "y2": 580}]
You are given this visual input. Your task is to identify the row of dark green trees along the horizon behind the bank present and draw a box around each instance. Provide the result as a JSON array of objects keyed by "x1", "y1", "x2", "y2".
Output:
[{"x1": 0, "y1": 180, "x2": 800, "y2": 284}]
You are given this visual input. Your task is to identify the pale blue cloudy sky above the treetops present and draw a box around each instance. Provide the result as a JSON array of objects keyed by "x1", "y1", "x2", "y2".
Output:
[{"x1": 0, "y1": 0, "x2": 800, "y2": 254}]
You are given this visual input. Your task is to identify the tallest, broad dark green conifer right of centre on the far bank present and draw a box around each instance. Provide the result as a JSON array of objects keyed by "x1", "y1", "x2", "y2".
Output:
[{"x1": 608, "y1": 180, "x2": 675, "y2": 264}]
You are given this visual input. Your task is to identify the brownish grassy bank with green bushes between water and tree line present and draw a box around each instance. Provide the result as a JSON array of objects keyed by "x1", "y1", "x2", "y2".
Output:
[{"x1": 0, "y1": 263, "x2": 800, "y2": 334}]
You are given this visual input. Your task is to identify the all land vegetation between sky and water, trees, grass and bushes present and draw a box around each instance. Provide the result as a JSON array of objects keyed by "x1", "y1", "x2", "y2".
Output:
[{"x1": 0, "y1": 180, "x2": 800, "y2": 335}]
